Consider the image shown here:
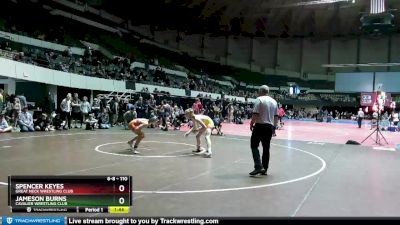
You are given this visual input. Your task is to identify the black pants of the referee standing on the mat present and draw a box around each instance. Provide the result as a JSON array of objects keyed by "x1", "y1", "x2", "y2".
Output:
[{"x1": 251, "y1": 123, "x2": 274, "y2": 170}]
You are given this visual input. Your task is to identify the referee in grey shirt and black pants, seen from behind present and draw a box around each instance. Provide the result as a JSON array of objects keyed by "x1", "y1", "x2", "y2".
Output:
[{"x1": 250, "y1": 85, "x2": 278, "y2": 176}]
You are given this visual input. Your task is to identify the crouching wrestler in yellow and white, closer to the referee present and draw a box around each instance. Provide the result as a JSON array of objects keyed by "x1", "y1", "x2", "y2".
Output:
[{"x1": 185, "y1": 108, "x2": 214, "y2": 158}]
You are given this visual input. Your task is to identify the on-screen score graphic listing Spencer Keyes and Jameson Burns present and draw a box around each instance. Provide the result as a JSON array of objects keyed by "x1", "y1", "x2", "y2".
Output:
[{"x1": 8, "y1": 175, "x2": 132, "y2": 213}]
